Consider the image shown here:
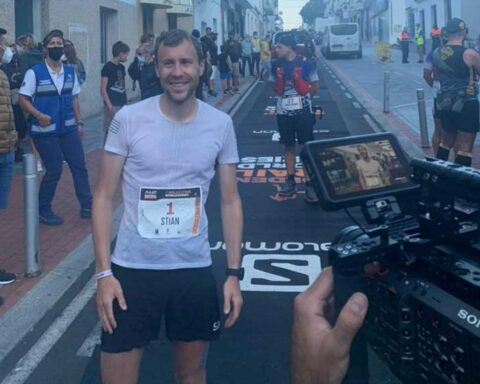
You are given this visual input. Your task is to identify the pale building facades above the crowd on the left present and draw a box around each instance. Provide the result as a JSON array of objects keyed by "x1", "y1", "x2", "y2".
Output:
[{"x1": 0, "y1": 0, "x2": 278, "y2": 117}]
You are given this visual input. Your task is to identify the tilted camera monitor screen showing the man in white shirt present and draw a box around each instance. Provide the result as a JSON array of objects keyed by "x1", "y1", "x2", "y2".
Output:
[{"x1": 302, "y1": 133, "x2": 418, "y2": 209}]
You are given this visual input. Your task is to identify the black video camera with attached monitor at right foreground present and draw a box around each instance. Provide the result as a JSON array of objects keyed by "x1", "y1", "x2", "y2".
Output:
[{"x1": 302, "y1": 134, "x2": 480, "y2": 384}]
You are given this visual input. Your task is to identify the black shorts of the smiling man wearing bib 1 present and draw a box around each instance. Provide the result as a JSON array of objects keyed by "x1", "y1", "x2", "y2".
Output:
[{"x1": 101, "y1": 264, "x2": 220, "y2": 353}]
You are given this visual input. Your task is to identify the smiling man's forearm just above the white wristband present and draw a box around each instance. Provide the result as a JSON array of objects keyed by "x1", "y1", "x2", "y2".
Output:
[{"x1": 92, "y1": 195, "x2": 113, "y2": 273}]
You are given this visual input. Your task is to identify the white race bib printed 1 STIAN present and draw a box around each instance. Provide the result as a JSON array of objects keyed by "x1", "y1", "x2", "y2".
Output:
[{"x1": 137, "y1": 187, "x2": 202, "y2": 239}]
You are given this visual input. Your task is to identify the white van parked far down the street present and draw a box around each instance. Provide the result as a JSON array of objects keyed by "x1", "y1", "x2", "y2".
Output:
[{"x1": 322, "y1": 23, "x2": 362, "y2": 59}]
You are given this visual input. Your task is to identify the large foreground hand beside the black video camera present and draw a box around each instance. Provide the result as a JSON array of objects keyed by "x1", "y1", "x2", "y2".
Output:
[{"x1": 291, "y1": 268, "x2": 368, "y2": 384}]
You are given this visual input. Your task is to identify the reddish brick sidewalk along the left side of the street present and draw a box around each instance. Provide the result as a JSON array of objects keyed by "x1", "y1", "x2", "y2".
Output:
[{"x1": 0, "y1": 73, "x2": 256, "y2": 316}]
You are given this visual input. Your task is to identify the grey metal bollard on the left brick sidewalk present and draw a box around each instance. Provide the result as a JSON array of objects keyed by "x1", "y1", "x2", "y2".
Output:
[{"x1": 23, "y1": 153, "x2": 42, "y2": 277}]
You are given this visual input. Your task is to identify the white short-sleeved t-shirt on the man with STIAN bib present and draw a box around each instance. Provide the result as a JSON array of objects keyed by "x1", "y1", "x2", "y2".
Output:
[{"x1": 105, "y1": 96, "x2": 239, "y2": 269}]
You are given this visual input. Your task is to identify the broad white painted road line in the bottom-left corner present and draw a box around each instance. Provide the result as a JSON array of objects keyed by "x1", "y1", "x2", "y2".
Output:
[{"x1": 2, "y1": 278, "x2": 97, "y2": 384}]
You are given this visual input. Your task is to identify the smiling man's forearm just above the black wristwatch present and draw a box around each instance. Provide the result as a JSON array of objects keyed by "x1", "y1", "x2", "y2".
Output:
[{"x1": 221, "y1": 197, "x2": 243, "y2": 268}]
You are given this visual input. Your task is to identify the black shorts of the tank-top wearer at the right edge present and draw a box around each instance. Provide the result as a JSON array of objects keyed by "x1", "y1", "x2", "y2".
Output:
[{"x1": 440, "y1": 100, "x2": 480, "y2": 133}]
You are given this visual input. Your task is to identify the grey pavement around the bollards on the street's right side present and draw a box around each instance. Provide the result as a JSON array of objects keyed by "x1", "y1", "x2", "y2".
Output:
[{"x1": 322, "y1": 42, "x2": 480, "y2": 168}]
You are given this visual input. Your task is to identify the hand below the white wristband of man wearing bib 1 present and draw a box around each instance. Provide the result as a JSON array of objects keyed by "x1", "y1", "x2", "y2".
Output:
[{"x1": 97, "y1": 276, "x2": 127, "y2": 334}]
